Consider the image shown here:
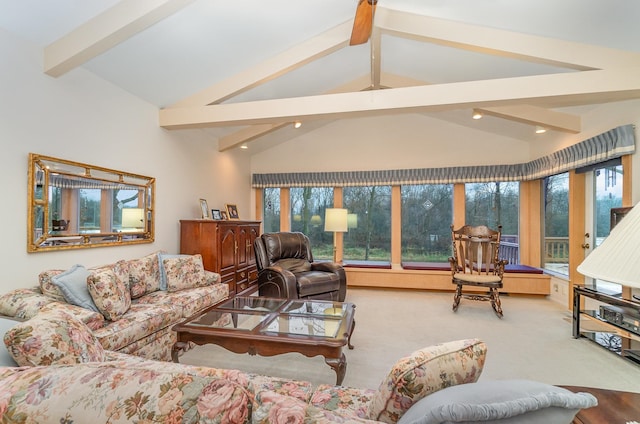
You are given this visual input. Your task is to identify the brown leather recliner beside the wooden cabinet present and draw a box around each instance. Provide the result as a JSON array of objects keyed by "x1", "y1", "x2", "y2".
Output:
[{"x1": 254, "y1": 232, "x2": 347, "y2": 302}]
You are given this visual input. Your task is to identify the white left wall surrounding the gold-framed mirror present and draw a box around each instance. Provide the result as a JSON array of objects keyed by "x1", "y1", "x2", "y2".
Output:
[{"x1": 0, "y1": 30, "x2": 250, "y2": 293}]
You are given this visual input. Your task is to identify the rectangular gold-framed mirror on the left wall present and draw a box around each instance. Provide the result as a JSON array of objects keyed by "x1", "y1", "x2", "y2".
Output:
[{"x1": 27, "y1": 153, "x2": 155, "y2": 252}]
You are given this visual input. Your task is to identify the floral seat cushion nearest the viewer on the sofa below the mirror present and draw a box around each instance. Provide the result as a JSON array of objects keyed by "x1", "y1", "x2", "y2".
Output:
[{"x1": 93, "y1": 304, "x2": 182, "y2": 351}]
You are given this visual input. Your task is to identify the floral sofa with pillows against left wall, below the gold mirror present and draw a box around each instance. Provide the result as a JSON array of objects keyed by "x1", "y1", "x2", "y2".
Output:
[{"x1": 0, "y1": 252, "x2": 229, "y2": 361}]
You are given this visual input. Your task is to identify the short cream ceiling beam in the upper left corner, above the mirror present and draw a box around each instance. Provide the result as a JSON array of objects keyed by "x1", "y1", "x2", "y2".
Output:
[{"x1": 44, "y1": 0, "x2": 194, "y2": 77}]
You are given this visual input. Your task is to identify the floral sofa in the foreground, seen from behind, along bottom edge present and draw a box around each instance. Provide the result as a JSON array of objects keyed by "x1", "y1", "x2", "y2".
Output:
[{"x1": 0, "y1": 309, "x2": 594, "y2": 424}]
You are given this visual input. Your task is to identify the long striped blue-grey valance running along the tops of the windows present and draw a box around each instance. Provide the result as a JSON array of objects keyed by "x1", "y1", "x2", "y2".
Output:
[{"x1": 252, "y1": 125, "x2": 635, "y2": 188}]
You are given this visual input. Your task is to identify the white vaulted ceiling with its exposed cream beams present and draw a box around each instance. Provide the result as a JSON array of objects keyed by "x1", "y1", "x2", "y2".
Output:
[{"x1": 0, "y1": 0, "x2": 640, "y2": 151}]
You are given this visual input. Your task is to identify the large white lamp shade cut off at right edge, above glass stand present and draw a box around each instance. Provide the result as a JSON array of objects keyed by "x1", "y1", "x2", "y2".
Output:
[{"x1": 578, "y1": 201, "x2": 640, "y2": 288}]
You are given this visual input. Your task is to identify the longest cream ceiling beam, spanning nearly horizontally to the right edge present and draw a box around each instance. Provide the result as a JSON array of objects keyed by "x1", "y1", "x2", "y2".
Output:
[{"x1": 159, "y1": 65, "x2": 640, "y2": 129}]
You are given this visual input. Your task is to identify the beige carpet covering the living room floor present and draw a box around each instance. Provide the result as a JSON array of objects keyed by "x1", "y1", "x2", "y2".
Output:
[{"x1": 180, "y1": 289, "x2": 640, "y2": 392}]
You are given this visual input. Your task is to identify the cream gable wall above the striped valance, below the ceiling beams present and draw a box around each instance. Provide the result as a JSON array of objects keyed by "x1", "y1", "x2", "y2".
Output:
[{"x1": 251, "y1": 114, "x2": 529, "y2": 173}]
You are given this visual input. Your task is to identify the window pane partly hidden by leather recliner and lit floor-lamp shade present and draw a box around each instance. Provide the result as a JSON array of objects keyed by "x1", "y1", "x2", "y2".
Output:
[{"x1": 290, "y1": 187, "x2": 333, "y2": 259}]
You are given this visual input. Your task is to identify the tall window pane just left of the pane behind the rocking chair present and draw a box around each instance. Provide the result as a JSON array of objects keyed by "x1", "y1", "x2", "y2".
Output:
[{"x1": 401, "y1": 184, "x2": 453, "y2": 262}]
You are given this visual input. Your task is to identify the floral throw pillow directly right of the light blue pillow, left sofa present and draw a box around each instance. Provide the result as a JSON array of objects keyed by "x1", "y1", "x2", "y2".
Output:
[{"x1": 87, "y1": 267, "x2": 131, "y2": 321}]
